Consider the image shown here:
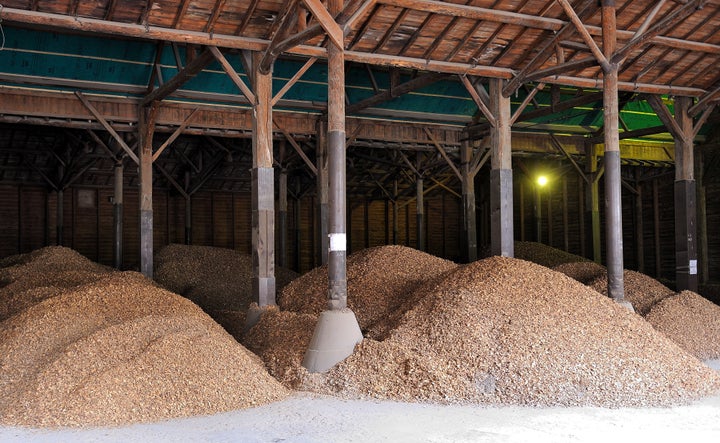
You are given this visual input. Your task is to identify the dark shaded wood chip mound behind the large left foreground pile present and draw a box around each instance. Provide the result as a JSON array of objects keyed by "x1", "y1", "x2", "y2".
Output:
[{"x1": 154, "y1": 244, "x2": 298, "y2": 332}]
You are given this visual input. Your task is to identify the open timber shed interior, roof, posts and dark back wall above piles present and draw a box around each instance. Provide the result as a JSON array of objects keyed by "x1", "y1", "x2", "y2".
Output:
[{"x1": 0, "y1": 0, "x2": 720, "y2": 334}]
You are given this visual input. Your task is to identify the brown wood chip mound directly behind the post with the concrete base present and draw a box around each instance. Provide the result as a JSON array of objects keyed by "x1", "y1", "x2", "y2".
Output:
[{"x1": 278, "y1": 245, "x2": 458, "y2": 330}]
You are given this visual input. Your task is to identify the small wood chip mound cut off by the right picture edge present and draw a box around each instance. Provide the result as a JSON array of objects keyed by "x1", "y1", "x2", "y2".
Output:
[{"x1": 645, "y1": 291, "x2": 720, "y2": 360}]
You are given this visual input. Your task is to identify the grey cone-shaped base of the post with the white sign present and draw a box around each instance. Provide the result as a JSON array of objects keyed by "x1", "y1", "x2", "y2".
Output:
[{"x1": 303, "y1": 309, "x2": 363, "y2": 372}]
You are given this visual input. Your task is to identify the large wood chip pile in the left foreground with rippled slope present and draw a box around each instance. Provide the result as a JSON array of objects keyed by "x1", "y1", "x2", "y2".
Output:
[{"x1": 0, "y1": 248, "x2": 288, "y2": 427}]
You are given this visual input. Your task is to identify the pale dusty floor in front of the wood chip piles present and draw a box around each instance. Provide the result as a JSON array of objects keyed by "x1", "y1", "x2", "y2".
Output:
[{"x1": 0, "y1": 360, "x2": 720, "y2": 443}]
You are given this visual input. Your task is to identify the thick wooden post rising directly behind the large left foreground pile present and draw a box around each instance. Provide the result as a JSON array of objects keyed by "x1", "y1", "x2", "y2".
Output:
[{"x1": 138, "y1": 102, "x2": 159, "y2": 278}]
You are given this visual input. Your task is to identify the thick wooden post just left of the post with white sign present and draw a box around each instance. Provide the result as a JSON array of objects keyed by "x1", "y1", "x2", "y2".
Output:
[{"x1": 252, "y1": 53, "x2": 275, "y2": 308}]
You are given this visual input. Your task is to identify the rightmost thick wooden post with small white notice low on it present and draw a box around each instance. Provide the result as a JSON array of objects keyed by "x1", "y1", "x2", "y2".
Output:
[{"x1": 675, "y1": 97, "x2": 698, "y2": 292}]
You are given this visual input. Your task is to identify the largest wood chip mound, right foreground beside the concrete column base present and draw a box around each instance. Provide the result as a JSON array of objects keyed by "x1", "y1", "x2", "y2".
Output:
[{"x1": 249, "y1": 257, "x2": 720, "y2": 407}]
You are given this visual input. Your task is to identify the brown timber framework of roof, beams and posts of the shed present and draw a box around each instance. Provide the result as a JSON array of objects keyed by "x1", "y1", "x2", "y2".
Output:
[{"x1": 0, "y1": 0, "x2": 720, "y2": 334}]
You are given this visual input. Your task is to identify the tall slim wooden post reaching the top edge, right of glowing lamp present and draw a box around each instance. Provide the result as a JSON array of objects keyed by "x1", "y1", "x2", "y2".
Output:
[{"x1": 602, "y1": 0, "x2": 625, "y2": 303}]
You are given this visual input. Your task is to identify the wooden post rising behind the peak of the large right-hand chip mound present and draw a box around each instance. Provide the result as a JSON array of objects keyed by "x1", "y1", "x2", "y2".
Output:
[{"x1": 490, "y1": 78, "x2": 515, "y2": 257}]
